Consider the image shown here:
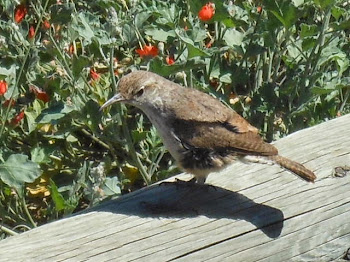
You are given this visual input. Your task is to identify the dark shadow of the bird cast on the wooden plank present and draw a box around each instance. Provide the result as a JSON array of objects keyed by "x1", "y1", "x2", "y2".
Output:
[{"x1": 88, "y1": 183, "x2": 284, "y2": 238}]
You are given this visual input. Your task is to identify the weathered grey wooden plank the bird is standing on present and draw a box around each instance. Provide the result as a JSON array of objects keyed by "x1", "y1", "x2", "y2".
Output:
[{"x1": 0, "y1": 115, "x2": 350, "y2": 261}]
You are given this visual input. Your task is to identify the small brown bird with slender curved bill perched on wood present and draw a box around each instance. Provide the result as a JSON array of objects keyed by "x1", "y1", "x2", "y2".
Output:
[{"x1": 101, "y1": 71, "x2": 316, "y2": 183}]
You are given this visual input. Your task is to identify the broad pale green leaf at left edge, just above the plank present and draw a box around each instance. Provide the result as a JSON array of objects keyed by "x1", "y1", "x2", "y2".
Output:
[{"x1": 0, "y1": 154, "x2": 41, "y2": 193}]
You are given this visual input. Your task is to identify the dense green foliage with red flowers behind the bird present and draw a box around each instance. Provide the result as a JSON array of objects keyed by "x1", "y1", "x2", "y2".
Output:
[{"x1": 0, "y1": 0, "x2": 350, "y2": 237}]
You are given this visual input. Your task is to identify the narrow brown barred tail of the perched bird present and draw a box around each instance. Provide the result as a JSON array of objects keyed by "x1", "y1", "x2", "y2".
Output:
[{"x1": 268, "y1": 155, "x2": 316, "y2": 182}]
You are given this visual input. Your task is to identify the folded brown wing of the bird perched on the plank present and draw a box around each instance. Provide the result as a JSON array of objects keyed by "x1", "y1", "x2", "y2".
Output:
[{"x1": 172, "y1": 89, "x2": 278, "y2": 155}]
